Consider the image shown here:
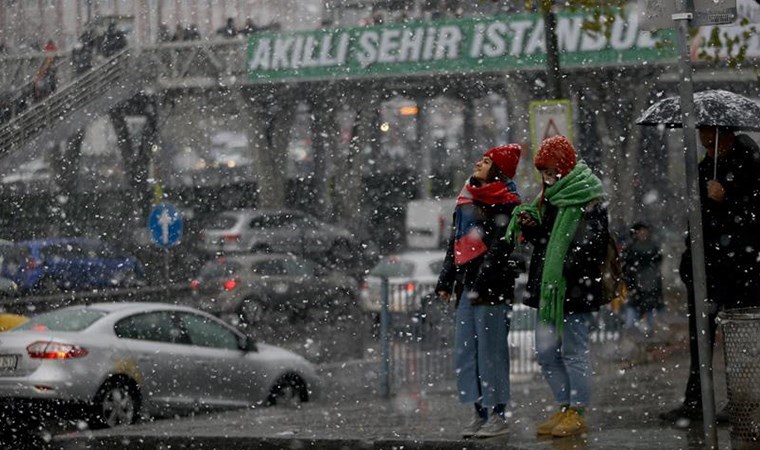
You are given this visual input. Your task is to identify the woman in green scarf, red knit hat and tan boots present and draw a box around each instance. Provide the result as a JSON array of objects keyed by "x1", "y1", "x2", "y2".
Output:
[{"x1": 507, "y1": 136, "x2": 608, "y2": 437}]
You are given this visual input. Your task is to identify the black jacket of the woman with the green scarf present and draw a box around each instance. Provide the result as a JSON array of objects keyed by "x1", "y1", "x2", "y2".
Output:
[{"x1": 522, "y1": 201, "x2": 608, "y2": 314}]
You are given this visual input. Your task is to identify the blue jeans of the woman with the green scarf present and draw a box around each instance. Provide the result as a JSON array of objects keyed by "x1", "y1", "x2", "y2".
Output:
[{"x1": 536, "y1": 313, "x2": 591, "y2": 407}]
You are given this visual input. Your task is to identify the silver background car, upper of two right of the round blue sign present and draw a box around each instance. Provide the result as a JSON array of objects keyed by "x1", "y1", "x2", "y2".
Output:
[{"x1": 201, "y1": 209, "x2": 356, "y2": 258}]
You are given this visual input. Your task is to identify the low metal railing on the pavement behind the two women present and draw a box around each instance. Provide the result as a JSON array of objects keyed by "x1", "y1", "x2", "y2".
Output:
[{"x1": 380, "y1": 279, "x2": 621, "y2": 396}]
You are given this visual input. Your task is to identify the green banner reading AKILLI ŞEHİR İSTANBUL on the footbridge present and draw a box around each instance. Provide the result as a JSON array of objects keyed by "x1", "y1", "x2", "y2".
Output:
[{"x1": 247, "y1": 9, "x2": 676, "y2": 82}]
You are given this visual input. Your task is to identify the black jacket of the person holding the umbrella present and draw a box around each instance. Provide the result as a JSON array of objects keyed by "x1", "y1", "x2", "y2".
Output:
[{"x1": 680, "y1": 135, "x2": 760, "y2": 284}]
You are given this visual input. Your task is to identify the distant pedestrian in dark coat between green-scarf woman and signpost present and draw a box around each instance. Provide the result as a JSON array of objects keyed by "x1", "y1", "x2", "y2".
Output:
[{"x1": 623, "y1": 222, "x2": 663, "y2": 336}]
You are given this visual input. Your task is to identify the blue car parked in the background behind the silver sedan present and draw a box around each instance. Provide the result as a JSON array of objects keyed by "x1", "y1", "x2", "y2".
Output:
[{"x1": 2, "y1": 238, "x2": 144, "y2": 294}]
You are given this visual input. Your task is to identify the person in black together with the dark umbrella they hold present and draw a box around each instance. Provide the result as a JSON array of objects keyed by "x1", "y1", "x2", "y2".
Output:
[{"x1": 636, "y1": 89, "x2": 760, "y2": 425}]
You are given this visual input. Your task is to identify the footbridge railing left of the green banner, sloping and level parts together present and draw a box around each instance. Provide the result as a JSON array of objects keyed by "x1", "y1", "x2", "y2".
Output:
[{"x1": 0, "y1": 40, "x2": 247, "y2": 157}]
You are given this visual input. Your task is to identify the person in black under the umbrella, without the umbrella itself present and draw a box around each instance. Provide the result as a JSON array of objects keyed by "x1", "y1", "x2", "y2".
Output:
[{"x1": 660, "y1": 126, "x2": 760, "y2": 424}]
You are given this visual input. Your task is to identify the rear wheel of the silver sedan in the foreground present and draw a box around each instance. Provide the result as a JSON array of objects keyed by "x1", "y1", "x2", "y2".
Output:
[{"x1": 94, "y1": 380, "x2": 140, "y2": 428}]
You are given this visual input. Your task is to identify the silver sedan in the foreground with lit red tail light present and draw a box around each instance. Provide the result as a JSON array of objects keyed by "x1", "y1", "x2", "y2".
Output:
[{"x1": 0, "y1": 303, "x2": 318, "y2": 427}]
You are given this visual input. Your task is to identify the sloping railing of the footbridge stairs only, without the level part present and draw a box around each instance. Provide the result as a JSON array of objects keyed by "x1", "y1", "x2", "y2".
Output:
[{"x1": 0, "y1": 49, "x2": 141, "y2": 157}]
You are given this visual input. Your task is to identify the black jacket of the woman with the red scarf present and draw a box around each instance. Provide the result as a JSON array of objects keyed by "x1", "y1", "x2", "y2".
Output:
[{"x1": 436, "y1": 197, "x2": 517, "y2": 305}]
